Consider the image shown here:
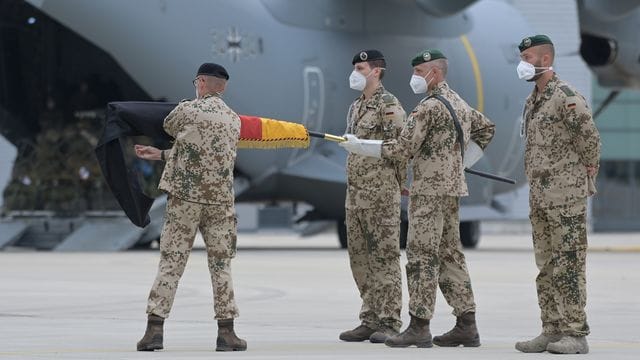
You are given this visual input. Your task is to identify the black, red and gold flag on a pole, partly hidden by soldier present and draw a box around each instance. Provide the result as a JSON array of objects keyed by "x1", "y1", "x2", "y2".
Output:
[{"x1": 95, "y1": 102, "x2": 332, "y2": 227}]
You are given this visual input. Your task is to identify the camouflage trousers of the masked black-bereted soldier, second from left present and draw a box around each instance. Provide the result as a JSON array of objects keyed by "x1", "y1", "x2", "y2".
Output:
[{"x1": 346, "y1": 205, "x2": 402, "y2": 330}]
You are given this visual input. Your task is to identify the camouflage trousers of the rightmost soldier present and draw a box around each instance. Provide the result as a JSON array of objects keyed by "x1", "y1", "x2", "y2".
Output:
[{"x1": 529, "y1": 199, "x2": 589, "y2": 336}]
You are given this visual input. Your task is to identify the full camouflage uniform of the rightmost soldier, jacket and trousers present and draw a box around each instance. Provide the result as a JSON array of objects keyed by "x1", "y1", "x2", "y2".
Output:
[{"x1": 523, "y1": 74, "x2": 600, "y2": 336}]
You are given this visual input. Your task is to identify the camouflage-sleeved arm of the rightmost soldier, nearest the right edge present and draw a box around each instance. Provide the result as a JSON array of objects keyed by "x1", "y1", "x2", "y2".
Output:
[{"x1": 563, "y1": 94, "x2": 601, "y2": 173}]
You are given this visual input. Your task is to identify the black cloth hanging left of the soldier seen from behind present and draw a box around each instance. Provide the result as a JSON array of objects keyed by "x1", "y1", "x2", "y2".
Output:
[{"x1": 96, "y1": 101, "x2": 177, "y2": 227}]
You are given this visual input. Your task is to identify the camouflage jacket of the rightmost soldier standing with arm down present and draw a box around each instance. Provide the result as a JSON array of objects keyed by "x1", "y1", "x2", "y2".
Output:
[{"x1": 523, "y1": 74, "x2": 600, "y2": 208}]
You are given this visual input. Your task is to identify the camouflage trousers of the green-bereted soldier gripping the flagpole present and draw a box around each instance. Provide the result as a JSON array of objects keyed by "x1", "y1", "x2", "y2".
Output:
[{"x1": 407, "y1": 195, "x2": 476, "y2": 319}]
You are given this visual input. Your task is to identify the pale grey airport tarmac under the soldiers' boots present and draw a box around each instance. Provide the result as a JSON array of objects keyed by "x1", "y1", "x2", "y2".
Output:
[{"x1": 0, "y1": 231, "x2": 640, "y2": 359}]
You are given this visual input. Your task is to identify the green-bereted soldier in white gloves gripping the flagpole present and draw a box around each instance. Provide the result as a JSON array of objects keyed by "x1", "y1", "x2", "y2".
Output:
[{"x1": 341, "y1": 49, "x2": 494, "y2": 347}]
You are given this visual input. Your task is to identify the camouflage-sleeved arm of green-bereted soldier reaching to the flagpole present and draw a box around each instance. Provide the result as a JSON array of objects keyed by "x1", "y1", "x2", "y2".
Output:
[{"x1": 382, "y1": 105, "x2": 431, "y2": 161}]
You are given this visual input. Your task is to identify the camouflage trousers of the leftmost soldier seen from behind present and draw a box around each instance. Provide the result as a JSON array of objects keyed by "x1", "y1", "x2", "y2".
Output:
[{"x1": 147, "y1": 195, "x2": 238, "y2": 319}]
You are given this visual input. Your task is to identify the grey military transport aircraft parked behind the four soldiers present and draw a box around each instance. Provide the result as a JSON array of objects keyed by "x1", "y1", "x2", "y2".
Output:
[{"x1": 1, "y1": 0, "x2": 640, "y2": 250}]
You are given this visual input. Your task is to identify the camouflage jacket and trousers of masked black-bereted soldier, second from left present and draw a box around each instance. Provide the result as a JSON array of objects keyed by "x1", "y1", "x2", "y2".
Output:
[{"x1": 345, "y1": 85, "x2": 406, "y2": 330}]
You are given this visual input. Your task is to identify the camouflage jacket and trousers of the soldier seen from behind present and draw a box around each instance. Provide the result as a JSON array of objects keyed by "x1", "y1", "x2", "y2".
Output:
[{"x1": 147, "y1": 96, "x2": 240, "y2": 319}]
